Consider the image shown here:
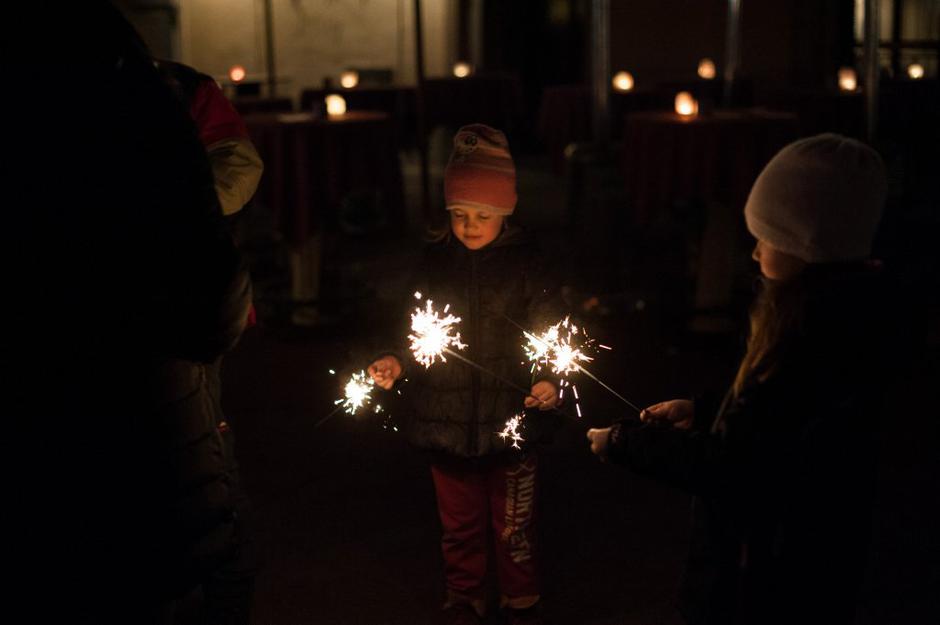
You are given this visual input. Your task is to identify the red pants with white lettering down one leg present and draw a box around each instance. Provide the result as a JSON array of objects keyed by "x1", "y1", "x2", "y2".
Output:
[{"x1": 431, "y1": 455, "x2": 539, "y2": 614}]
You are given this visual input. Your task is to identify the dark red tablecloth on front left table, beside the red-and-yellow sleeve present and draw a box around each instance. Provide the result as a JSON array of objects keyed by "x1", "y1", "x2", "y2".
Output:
[{"x1": 245, "y1": 112, "x2": 402, "y2": 247}]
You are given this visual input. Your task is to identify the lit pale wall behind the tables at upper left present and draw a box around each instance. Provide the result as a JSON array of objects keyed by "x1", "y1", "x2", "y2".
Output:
[{"x1": 179, "y1": 0, "x2": 457, "y2": 98}]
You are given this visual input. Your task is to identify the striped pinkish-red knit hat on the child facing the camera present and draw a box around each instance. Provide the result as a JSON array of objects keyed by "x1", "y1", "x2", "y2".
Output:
[{"x1": 444, "y1": 124, "x2": 516, "y2": 215}]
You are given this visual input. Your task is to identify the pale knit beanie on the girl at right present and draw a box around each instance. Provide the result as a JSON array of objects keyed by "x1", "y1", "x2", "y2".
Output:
[{"x1": 744, "y1": 133, "x2": 888, "y2": 263}]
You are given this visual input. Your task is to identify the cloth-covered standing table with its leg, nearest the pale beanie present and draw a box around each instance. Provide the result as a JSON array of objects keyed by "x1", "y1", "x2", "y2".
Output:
[{"x1": 623, "y1": 109, "x2": 798, "y2": 320}]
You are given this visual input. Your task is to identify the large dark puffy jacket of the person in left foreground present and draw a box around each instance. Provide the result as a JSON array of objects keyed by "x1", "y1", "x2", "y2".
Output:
[{"x1": 2, "y1": 2, "x2": 251, "y2": 623}]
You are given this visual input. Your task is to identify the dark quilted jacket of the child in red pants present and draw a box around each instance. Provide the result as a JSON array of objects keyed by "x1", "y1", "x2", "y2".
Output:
[{"x1": 392, "y1": 227, "x2": 563, "y2": 458}]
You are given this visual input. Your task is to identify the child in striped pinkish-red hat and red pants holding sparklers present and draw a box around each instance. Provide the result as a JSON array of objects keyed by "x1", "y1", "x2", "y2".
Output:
[{"x1": 369, "y1": 124, "x2": 561, "y2": 624}]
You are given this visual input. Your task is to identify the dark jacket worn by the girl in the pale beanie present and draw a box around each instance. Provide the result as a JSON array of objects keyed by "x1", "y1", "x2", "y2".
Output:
[{"x1": 611, "y1": 266, "x2": 891, "y2": 625}]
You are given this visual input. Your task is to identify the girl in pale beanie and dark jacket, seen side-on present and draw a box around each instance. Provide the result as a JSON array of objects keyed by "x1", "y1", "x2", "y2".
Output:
[{"x1": 588, "y1": 134, "x2": 894, "y2": 625}]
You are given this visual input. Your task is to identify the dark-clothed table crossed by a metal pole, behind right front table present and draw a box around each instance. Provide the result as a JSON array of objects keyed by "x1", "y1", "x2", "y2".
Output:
[{"x1": 536, "y1": 84, "x2": 671, "y2": 174}]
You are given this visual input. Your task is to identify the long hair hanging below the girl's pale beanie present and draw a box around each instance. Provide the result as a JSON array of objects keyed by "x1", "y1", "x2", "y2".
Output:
[{"x1": 732, "y1": 273, "x2": 807, "y2": 397}]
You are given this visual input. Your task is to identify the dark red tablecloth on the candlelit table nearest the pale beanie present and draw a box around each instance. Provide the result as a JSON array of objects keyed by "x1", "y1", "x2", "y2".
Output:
[{"x1": 623, "y1": 109, "x2": 797, "y2": 224}]
